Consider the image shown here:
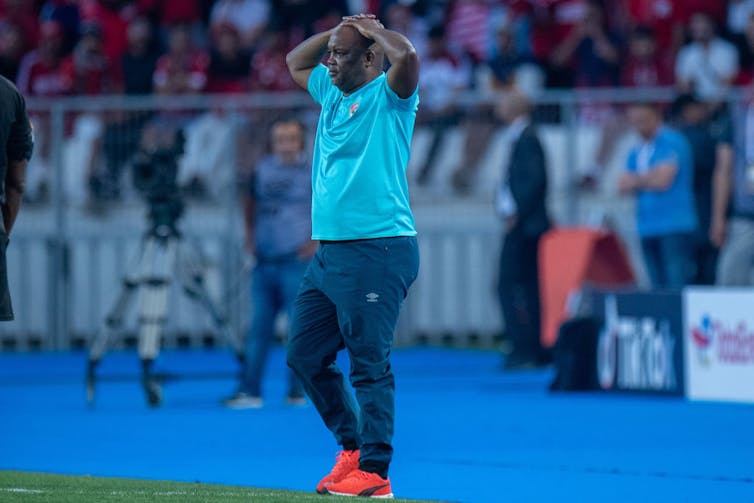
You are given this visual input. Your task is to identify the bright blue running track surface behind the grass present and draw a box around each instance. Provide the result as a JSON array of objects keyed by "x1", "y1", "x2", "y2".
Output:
[{"x1": 0, "y1": 348, "x2": 754, "y2": 503}]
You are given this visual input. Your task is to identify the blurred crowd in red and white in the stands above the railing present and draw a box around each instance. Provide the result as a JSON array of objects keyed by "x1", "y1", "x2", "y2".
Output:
[{"x1": 0, "y1": 0, "x2": 754, "y2": 97}]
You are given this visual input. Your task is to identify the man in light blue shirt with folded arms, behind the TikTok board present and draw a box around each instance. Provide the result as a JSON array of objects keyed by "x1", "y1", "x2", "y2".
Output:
[{"x1": 618, "y1": 103, "x2": 697, "y2": 289}]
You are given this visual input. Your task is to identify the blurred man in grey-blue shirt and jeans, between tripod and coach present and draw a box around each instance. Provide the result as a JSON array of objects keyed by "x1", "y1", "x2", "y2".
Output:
[{"x1": 225, "y1": 117, "x2": 317, "y2": 409}]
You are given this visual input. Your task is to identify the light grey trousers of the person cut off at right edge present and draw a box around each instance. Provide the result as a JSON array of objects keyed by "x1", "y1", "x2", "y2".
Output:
[{"x1": 716, "y1": 218, "x2": 754, "y2": 286}]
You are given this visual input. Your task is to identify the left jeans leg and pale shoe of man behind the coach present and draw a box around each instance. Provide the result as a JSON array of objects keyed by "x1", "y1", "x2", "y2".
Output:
[{"x1": 225, "y1": 262, "x2": 280, "y2": 408}]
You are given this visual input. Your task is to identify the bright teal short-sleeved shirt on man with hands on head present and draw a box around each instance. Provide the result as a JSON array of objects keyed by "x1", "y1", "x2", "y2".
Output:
[{"x1": 308, "y1": 65, "x2": 419, "y2": 241}]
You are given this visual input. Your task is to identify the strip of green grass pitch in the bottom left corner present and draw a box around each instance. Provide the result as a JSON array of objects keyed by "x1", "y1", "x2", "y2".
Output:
[{"x1": 0, "y1": 471, "x2": 440, "y2": 503}]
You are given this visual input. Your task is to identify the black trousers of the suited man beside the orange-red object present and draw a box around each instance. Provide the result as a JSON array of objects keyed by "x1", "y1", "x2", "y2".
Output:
[{"x1": 498, "y1": 227, "x2": 543, "y2": 363}]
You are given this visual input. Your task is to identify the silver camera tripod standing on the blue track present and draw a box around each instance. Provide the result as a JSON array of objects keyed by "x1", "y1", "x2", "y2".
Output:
[{"x1": 86, "y1": 222, "x2": 243, "y2": 407}]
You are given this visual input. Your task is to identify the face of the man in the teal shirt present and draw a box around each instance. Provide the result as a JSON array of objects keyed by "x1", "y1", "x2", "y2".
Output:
[{"x1": 327, "y1": 26, "x2": 367, "y2": 93}]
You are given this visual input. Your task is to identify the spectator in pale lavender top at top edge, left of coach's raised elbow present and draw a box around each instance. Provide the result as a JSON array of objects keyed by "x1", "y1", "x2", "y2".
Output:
[{"x1": 209, "y1": 0, "x2": 272, "y2": 51}]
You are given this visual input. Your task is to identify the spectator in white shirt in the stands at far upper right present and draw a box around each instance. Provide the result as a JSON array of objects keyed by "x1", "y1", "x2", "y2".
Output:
[{"x1": 675, "y1": 12, "x2": 738, "y2": 100}]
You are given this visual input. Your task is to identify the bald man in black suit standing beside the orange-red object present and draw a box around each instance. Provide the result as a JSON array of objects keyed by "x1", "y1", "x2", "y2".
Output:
[{"x1": 496, "y1": 91, "x2": 550, "y2": 370}]
